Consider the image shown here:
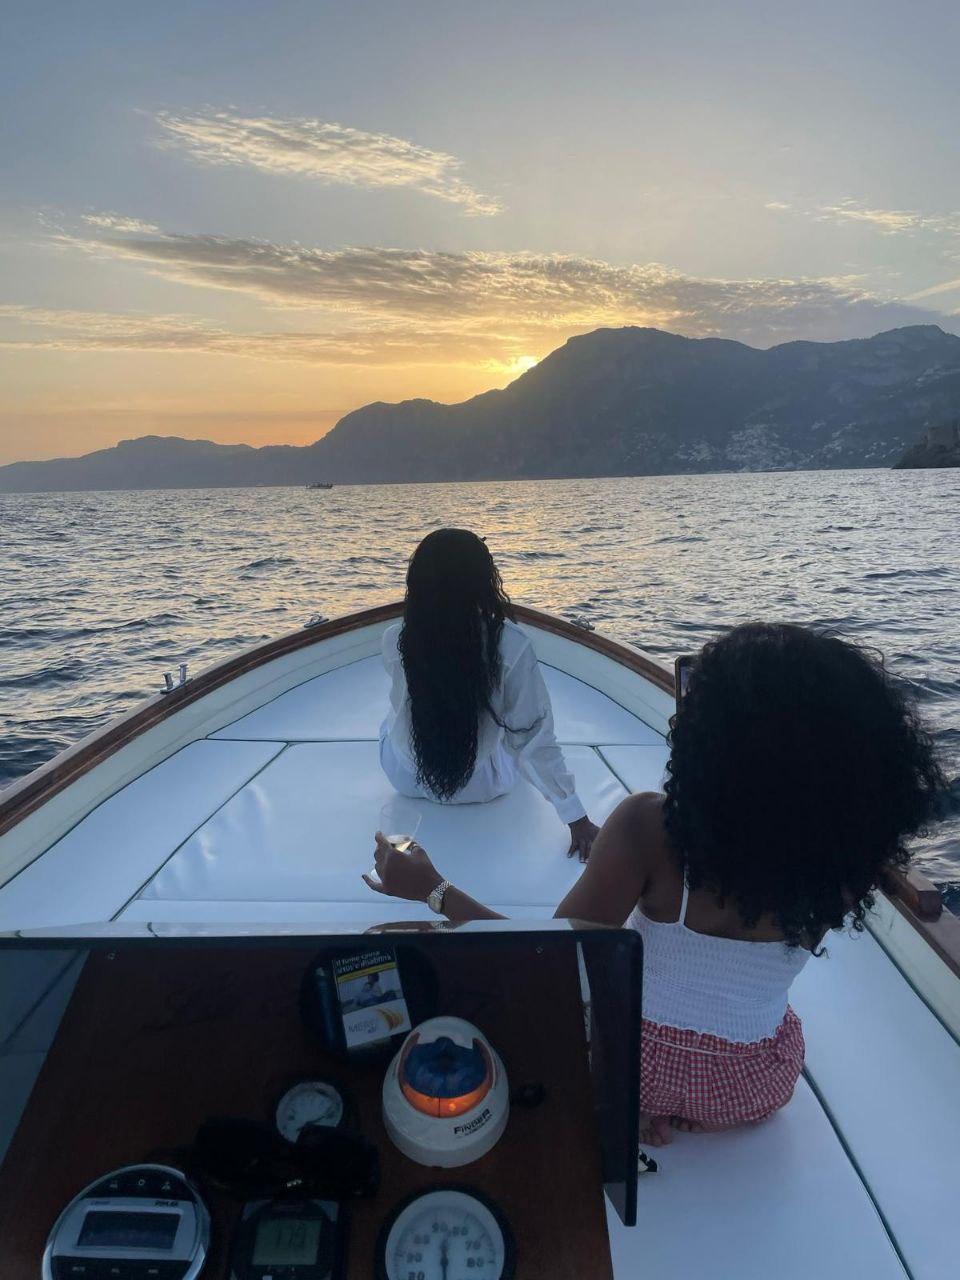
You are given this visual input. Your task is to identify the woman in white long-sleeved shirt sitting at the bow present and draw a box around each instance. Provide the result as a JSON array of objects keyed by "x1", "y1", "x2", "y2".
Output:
[{"x1": 380, "y1": 529, "x2": 596, "y2": 860}]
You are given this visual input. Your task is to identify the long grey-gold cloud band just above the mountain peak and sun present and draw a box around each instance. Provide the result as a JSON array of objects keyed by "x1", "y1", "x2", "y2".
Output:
[{"x1": 61, "y1": 218, "x2": 957, "y2": 355}]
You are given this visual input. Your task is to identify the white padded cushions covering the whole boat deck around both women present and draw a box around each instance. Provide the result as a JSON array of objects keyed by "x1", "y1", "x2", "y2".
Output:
[{"x1": 0, "y1": 645, "x2": 960, "y2": 1280}]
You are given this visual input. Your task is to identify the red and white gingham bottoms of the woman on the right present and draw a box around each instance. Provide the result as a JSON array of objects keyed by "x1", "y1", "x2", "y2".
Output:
[{"x1": 640, "y1": 1007, "x2": 804, "y2": 1125}]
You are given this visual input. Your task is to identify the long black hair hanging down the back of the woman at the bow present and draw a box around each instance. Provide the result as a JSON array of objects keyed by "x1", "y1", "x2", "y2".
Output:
[{"x1": 398, "y1": 529, "x2": 513, "y2": 800}]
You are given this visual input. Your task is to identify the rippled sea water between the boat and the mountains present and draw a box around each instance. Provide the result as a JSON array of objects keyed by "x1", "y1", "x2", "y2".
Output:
[{"x1": 0, "y1": 471, "x2": 960, "y2": 881}]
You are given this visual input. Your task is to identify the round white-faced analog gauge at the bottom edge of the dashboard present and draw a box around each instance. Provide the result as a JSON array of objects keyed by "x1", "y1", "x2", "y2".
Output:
[{"x1": 376, "y1": 1187, "x2": 516, "y2": 1280}]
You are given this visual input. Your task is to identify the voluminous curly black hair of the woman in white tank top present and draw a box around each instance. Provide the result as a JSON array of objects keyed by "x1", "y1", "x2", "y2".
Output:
[{"x1": 663, "y1": 622, "x2": 945, "y2": 947}]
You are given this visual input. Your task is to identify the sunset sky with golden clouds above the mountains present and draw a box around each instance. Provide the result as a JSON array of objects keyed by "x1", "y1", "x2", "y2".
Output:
[{"x1": 0, "y1": 0, "x2": 960, "y2": 463}]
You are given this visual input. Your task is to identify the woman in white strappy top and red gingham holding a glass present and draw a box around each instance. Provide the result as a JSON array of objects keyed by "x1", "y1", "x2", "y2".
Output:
[{"x1": 367, "y1": 623, "x2": 943, "y2": 1146}]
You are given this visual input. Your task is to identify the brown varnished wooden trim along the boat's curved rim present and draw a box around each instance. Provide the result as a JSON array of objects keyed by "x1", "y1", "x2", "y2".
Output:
[{"x1": 0, "y1": 600, "x2": 960, "y2": 975}]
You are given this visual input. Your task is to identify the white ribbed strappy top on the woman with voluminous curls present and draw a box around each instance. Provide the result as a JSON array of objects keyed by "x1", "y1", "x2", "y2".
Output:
[{"x1": 630, "y1": 881, "x2": 810, "y2": 1044}]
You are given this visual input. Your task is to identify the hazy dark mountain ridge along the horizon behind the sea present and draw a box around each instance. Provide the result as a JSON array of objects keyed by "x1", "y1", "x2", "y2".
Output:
[{"x1": 0, "y1": 325, "x2": 960, "y2": 493}]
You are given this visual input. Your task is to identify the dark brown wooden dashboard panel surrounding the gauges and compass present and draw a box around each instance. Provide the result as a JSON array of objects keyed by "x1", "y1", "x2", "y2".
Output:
[{"x1": 0, "y1": 938, "x2": 612, "y2": 1280}]
